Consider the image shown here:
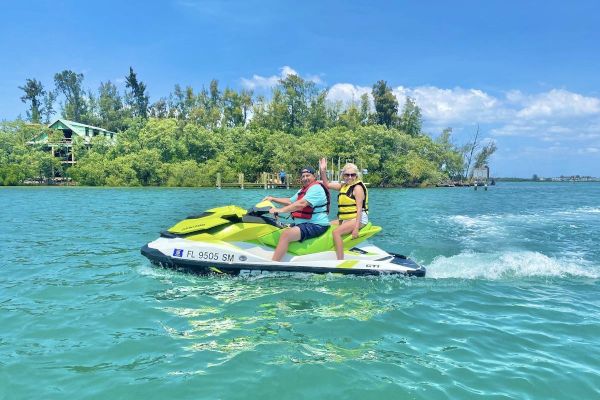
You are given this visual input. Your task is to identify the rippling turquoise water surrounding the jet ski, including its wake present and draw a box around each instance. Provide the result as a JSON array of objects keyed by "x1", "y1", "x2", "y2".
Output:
[{"x1": 0, "y1": 183, "x2": 600, "y2": 399}]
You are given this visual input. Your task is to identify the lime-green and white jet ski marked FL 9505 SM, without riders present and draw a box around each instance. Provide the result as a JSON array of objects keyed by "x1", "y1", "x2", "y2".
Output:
[{"x1": 141, "y1": 201, "x2": 425, "y2": 277}]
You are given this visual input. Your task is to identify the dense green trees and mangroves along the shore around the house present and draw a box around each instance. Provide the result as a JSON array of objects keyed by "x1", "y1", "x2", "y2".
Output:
[{"x1": 0, "y1": 68, "x2": 495, "y2": 186}]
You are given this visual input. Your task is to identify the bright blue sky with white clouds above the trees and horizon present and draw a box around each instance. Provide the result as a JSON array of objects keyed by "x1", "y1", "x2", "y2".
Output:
[{"x1": 0, "y1": 0, "x2": 600, "y2": 177}]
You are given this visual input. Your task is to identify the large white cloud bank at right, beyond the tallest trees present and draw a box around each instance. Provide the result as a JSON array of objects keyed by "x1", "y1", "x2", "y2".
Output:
[{"x1": 384, "y1": 86, "x2": 600, "y2": 144}]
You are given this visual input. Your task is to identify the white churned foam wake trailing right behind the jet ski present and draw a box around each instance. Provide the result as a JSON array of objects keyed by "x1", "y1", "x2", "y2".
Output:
[{"x1": 427, "y1": 251, "x2": 600, "y2": 280}]
